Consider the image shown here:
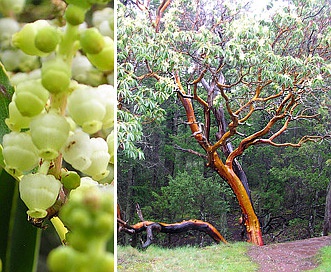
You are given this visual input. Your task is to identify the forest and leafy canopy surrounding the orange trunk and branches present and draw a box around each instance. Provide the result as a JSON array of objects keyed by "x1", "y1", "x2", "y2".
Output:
[{"x1": 117, "y1": 0, "x2": 331, "y2": 246}]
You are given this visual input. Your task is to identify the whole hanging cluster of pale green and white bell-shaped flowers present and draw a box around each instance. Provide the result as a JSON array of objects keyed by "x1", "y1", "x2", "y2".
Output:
[{"x1": 0, "y1": 0, "x2": 116, "y2": 271}]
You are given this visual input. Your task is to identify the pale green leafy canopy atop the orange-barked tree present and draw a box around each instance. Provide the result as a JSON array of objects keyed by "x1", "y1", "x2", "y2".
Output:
[{"x1": 118, "y1": 1, "x2": 331, "y2": 157}]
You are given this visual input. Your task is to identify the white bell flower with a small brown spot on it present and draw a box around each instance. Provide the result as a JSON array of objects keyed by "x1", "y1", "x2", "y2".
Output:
[{"x1": 62, "y1": 130, "x2": 92, "y2": 171}]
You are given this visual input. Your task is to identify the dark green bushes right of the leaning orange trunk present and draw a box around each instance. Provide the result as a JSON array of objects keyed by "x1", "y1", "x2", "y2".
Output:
[{"x1": 242, "y1": 135, "x2": 330, "y2": 239}]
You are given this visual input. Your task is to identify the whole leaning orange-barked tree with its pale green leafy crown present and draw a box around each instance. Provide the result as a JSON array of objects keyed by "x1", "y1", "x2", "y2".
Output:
[{"x1": 118, "y1": 0, "x2": 331, "y2": 245}]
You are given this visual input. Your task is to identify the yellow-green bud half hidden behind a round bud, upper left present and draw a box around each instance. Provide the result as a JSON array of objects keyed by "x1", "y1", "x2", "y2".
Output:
[{"x1": 12, "y1": 20, "x2": 49, "y2": 56}]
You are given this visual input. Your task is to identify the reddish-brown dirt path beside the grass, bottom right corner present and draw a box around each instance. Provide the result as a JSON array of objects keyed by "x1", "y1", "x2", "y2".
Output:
[{"x1": 248, "y1": 236, "x2": 331, "y2": 272}]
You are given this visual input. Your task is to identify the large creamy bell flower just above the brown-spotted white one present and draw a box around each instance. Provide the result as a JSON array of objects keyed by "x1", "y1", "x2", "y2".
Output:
[{"x1": 68, "y1": 88, "x2": 106, "y2": 134}]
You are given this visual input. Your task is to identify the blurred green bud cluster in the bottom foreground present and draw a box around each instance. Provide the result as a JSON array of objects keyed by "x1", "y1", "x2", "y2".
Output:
[{"x1": 48, "y1": 177, "x2": 114, "y2": 272}]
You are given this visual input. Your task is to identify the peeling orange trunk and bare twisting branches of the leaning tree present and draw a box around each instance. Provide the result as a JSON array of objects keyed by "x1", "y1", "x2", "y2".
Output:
[{"x1": 175, "y1": 65, "x2": 325, "y2": 245}]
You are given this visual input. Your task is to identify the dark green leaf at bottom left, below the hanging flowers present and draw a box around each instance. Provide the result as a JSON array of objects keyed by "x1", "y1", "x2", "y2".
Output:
[{"x1": 0, "y1": 171, "x2": 41, "y2": 272}]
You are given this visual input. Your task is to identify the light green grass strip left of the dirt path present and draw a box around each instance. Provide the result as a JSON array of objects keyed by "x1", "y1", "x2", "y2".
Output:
[{"x1": 117, "y1": 243, "x2": 258, "y2": 272}]
